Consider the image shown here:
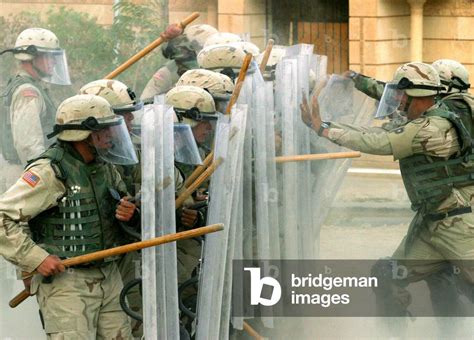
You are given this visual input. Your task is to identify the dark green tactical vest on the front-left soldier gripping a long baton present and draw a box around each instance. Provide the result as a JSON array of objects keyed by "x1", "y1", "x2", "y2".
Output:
[{"x1": 29, "y1": 143, "x2": 124, "y2": 258}]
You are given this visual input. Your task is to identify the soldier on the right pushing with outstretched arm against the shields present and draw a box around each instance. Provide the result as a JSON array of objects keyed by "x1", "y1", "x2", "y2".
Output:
[{"x1": 302, "y1": 63, "x2": 474, "y2": 316}]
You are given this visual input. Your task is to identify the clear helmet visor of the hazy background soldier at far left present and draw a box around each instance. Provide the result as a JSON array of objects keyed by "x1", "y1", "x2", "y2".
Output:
[{"x1": 33, "y1": 48, "x2": 71, "y2": 85}]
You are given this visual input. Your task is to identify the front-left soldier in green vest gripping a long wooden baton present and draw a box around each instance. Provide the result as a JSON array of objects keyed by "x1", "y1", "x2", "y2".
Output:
[{"x1": 0, "y1": 95, "x2": 137, "y2": 339}]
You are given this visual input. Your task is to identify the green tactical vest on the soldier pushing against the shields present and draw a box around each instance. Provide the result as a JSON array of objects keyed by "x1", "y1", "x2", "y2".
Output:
[{"x1": 400, "y1": 108, "x2": 474, "y2": 213}]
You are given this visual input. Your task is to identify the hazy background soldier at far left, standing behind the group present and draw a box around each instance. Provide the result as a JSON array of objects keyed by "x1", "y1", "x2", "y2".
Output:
[{"x1": 0, "y1": 28, "x2": 70, "y2": 193}]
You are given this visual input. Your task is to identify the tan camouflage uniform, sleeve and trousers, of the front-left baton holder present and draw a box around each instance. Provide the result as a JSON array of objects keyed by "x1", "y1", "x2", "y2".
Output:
[{"x1": 0, "y1": 141, "x2": 130, "y2": 339}]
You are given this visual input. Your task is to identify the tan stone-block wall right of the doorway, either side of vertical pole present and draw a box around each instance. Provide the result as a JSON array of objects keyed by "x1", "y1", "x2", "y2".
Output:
[{"x1": 349, "y1": 0, "x2": 474, "y2": 80}]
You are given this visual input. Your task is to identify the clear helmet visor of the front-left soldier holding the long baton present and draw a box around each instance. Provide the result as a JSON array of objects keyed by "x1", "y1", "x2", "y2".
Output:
[{"x1": 91, "y1": 116, "x2": 138, "y2": 165}]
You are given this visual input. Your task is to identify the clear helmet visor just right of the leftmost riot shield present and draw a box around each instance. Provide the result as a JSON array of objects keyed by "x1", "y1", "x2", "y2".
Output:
[{"x1": 174, "y1": 123, "x2": 202, "y2": 165}]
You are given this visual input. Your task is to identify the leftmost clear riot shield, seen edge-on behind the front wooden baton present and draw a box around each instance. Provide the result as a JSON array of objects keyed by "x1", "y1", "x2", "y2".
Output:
[{"x1": 142, "y1": 99, "x2": 179, "y2": 339}]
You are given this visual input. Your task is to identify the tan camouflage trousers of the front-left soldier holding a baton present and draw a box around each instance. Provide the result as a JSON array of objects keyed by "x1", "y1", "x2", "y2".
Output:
[{"x1": 31, "y1": 262, "x2": 133, "y2": 340}]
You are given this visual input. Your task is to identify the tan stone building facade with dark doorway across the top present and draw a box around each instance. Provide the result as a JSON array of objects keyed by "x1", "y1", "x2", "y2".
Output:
[{"x1": 0, "y1": 0, "x2": 474, "y2": 80}]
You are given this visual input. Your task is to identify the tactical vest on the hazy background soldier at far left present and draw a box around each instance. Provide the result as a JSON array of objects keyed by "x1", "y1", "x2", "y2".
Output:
[{"x1": 0, "y1": 75, "x2": 56, "y2": 164}]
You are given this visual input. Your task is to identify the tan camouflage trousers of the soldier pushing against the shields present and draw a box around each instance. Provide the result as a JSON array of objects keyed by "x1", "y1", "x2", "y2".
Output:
[{"x1": 377, "y1": 213, "x2": 474, "y2": 316}]
